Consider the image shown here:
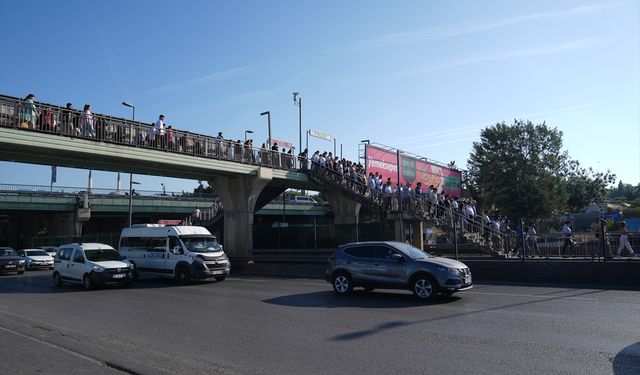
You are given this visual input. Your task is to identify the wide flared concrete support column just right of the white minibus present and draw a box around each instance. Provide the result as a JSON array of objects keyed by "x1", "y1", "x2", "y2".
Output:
[{"x1": 212, "y1": 168, "x2": 273, "y2": 259}]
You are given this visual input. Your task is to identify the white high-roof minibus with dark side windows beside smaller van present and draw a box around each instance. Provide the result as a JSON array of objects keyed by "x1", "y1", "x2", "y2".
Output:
[{"x1": 118, "y1": 224, "x2": 231, "y2": 283}]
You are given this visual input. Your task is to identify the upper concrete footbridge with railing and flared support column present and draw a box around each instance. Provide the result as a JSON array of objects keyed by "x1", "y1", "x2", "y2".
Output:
[{"x1": 0, "y1": 95, "x2": 360, "y2": 257}]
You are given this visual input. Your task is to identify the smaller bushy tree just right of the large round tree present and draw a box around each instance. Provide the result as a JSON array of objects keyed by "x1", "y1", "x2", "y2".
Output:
[{"x1": 565, "y1": 160, "x2": 616, "y2": 212}]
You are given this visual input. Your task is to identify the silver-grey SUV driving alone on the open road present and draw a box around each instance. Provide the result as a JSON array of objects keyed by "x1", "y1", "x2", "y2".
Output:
[{"x1": 325, "y1": 242, "x2": 473, "y2": 300}]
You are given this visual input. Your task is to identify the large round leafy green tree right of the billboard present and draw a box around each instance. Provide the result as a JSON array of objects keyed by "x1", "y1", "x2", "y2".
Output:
[{"x1": 467, "y1": 120, "x2": 569, "y2": 218}]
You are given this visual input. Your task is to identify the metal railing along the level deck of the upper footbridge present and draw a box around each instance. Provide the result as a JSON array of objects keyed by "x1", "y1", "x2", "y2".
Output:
[{"x1": 0, "y1": 95, "x2": 299, "y2": 170}]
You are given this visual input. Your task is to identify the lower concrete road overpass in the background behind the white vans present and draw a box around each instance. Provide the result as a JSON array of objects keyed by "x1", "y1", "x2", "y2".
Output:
[{"x1": 0, "y1": 184, "x2": 330, "y2": 247}]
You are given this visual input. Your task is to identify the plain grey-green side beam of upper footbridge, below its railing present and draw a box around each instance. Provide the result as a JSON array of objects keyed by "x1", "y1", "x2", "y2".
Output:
[{"x1": 0, "y1": 128, "x2": 323, "y2": 190}]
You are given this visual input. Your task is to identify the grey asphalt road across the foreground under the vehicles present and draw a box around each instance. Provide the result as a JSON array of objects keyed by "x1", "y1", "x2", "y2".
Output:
[{"x1": 0, "y1": 271, "x2": 640, "y2": 375}]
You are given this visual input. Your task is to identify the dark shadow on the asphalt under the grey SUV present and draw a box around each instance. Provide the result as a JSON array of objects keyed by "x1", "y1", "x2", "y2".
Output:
[{"x1": 262, "y1": 290, "x2": 460, "y2": 309}]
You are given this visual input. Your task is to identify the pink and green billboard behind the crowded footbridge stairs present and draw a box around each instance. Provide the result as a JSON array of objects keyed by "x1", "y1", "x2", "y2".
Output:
[{"x1": 365, "y1": 145, "x2": 462, "y2": 197}]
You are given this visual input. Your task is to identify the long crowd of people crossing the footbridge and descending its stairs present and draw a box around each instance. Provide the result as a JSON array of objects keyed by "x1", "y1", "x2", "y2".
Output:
[{"x1": 5, "y1": 94, "x2": 636, "y2": 256}]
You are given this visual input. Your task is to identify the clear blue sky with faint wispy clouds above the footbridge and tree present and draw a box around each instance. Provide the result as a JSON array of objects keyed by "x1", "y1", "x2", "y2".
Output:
[{"x1": 0, "y1": 0, "x2": 640, "y2": 191}]
